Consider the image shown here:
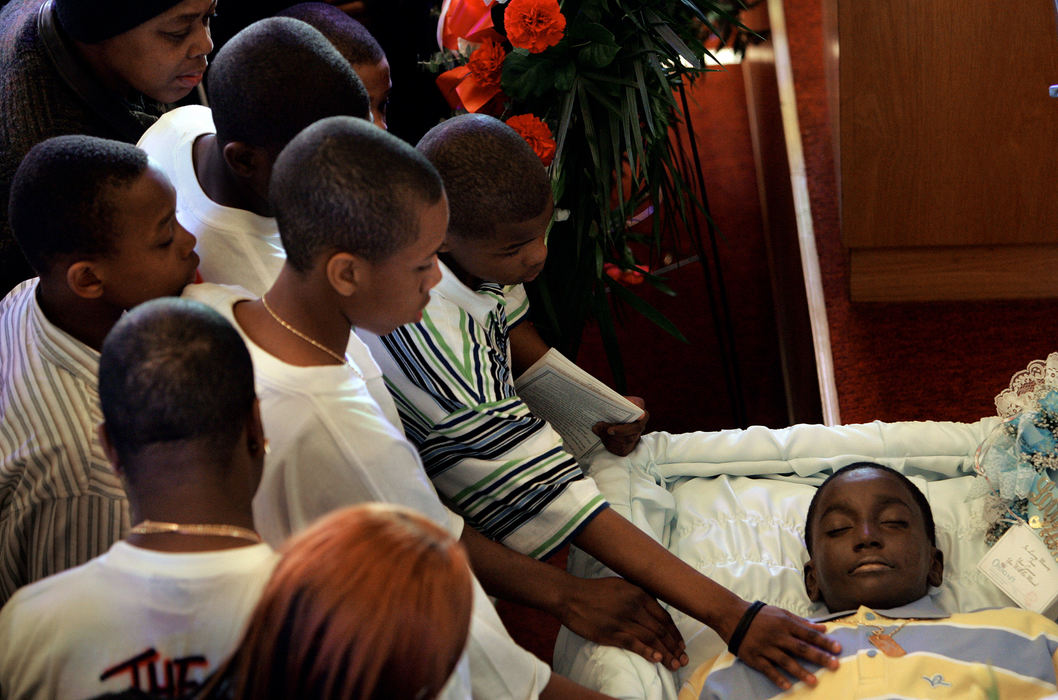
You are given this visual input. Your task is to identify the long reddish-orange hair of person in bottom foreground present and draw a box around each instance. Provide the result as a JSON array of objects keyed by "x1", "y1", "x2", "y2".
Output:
[{"x1": 218, "y1": 503, "x2": 473, "y2": 700}]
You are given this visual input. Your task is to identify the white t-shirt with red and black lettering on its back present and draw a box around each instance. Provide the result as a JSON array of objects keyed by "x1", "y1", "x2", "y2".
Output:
[{"x1": 0, "y1": 540, "x2": 278, "y2": 700}]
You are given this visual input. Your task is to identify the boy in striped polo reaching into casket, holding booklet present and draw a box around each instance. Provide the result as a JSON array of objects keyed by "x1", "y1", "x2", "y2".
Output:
[{"x1": 363, "y1": 114, "x2": 838, "y2": 687}]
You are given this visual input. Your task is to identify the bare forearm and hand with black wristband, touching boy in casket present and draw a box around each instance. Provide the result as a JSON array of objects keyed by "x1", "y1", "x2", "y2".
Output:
[{"x1": 573, "y1": 509, "x2": 841, "y2": 689}]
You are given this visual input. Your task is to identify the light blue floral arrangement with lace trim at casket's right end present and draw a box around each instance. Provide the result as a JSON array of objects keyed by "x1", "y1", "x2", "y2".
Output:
[{"x1": 971, "y1": 353, "x2": 1058, "y2": 547}]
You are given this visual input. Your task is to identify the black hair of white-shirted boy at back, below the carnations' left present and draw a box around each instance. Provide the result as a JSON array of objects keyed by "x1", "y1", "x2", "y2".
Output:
[{"x1": 207, "y1": 17, "x2": 371, "y2": 150}]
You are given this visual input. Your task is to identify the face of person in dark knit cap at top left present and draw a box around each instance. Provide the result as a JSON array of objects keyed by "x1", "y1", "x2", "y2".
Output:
[{"x1": 95, "y1": 0, "x2": 217, "y2": 104}]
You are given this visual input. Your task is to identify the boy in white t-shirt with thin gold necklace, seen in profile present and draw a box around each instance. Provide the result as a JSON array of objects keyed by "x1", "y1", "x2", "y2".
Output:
[{"x1": 186, "y1": 117, "x2": 588, "y2": 698}]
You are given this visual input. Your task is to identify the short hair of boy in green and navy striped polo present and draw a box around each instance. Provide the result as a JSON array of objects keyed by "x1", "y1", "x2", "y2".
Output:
[{"x1": 416, "y1": 114, "x2": 551, "y2": 239}]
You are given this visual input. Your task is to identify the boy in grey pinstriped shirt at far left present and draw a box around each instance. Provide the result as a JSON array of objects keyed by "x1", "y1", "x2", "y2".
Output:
[{"x1": 0, "y1": 135, "x2": 198, "y2": 604}]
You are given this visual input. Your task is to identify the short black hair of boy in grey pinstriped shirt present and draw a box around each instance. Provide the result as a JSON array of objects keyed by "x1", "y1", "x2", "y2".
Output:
[{"x1": 8, "y1": 134, "x2": 148, "y2": 275}]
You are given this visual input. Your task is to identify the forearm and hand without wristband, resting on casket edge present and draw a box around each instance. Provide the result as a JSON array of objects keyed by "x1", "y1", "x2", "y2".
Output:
[{"x1": 460, "y1": 526, "x2": 687, "y2": 669}]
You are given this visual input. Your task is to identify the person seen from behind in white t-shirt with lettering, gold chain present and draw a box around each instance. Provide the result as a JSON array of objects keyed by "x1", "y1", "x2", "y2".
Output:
[{"x1": 0, "y1": 298, "x2": 277, "y2": 698}]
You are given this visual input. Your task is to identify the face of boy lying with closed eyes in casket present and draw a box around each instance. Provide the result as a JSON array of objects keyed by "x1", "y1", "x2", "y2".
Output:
[{"x1": 804, "y1": 468, "x2": 944, "y2": 612}]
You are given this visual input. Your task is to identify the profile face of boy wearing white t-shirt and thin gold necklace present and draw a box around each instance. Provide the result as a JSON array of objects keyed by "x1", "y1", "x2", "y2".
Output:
[{"x1": 349, "y1": 196, "x2": 449, "y2": 335}]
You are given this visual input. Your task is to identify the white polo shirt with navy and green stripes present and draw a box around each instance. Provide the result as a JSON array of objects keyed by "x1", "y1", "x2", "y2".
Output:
[{"x1": 362, "y1": 264, "x2": 606, "y2": 557}]
